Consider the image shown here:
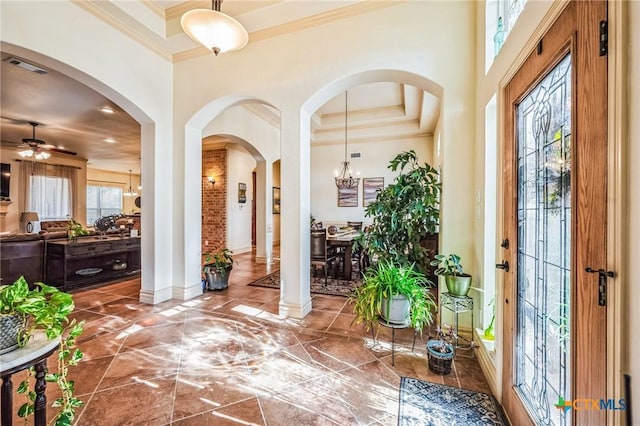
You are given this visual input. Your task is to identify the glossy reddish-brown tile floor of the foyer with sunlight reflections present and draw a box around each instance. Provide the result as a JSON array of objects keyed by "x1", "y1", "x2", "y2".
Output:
[{"x1": 8, "y1": 254, "x2": 489, "y2": 426}]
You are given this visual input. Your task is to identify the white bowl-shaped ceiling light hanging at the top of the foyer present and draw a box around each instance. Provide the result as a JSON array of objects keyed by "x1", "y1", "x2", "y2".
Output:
[{"x1": 180, "y1": 0, "x2": 249, "y2": 56}]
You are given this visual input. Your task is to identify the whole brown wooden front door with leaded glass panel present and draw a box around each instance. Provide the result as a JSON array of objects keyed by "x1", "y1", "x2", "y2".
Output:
[{"x1": 502, "y1": 1, "x2": 607, "y2": 425}]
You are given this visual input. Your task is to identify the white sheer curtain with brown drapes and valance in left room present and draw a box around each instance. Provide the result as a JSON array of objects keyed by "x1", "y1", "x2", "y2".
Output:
[{"x1": 20, "y1": 161, "x2": 78, "y2": 221}]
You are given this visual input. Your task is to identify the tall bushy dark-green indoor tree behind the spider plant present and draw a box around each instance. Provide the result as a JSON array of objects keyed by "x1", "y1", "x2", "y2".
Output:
[{"x1": 361, "y1": 150, "x2": 441, "y2": 272}]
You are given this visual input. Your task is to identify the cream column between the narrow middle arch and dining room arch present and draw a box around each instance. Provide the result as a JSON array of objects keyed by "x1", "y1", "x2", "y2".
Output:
[{"x1": 280, "y1": 108, "x2": 311, "y2": 318}]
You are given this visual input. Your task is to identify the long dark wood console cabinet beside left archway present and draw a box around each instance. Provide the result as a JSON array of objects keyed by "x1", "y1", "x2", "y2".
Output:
[{"x1": 45, "y1": 236, "x2": 140, "y2": 291}]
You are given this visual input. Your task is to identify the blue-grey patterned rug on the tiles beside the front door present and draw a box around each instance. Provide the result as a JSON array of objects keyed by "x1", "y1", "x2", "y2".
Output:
[{"x1": 398, "y1": 377, "x2": 508, "y2": 426}]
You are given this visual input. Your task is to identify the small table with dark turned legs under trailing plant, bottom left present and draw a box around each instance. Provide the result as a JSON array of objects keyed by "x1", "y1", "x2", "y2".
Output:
[{"x1": 0, "y1": 331, "x2": 60, "y2": 426}]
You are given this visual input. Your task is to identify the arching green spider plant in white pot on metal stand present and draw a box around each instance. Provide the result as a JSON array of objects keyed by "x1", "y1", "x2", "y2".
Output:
[{"x1": 349, "y1": 260, "x2": 437, "y2": 332}]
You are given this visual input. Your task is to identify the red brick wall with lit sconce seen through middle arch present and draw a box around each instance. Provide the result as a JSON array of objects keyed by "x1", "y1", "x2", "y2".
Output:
[{"x1": 201, "y1": 148, "x2": 228, "y2": 252}]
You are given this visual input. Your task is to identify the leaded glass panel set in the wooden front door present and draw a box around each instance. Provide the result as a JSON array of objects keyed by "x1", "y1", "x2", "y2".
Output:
[{"x1": 515, "y1": 55, "x2": 571, "y2": 425}]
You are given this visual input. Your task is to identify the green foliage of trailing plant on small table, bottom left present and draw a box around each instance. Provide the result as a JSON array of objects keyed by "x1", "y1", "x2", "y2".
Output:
[{"x1": 0, "y1": 277, "x2": 84, "y2": 426}]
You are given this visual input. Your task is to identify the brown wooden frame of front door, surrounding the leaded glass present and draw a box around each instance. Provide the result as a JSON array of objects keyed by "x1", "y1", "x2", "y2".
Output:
[{"x1": 502, "y1": 1, "x2": 608, "y2": 425}]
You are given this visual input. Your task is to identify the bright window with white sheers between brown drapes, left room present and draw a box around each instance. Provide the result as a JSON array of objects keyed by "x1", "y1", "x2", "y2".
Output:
[{"x1": 29, "y1": 175, "x2": 72, "y2": 221}]
